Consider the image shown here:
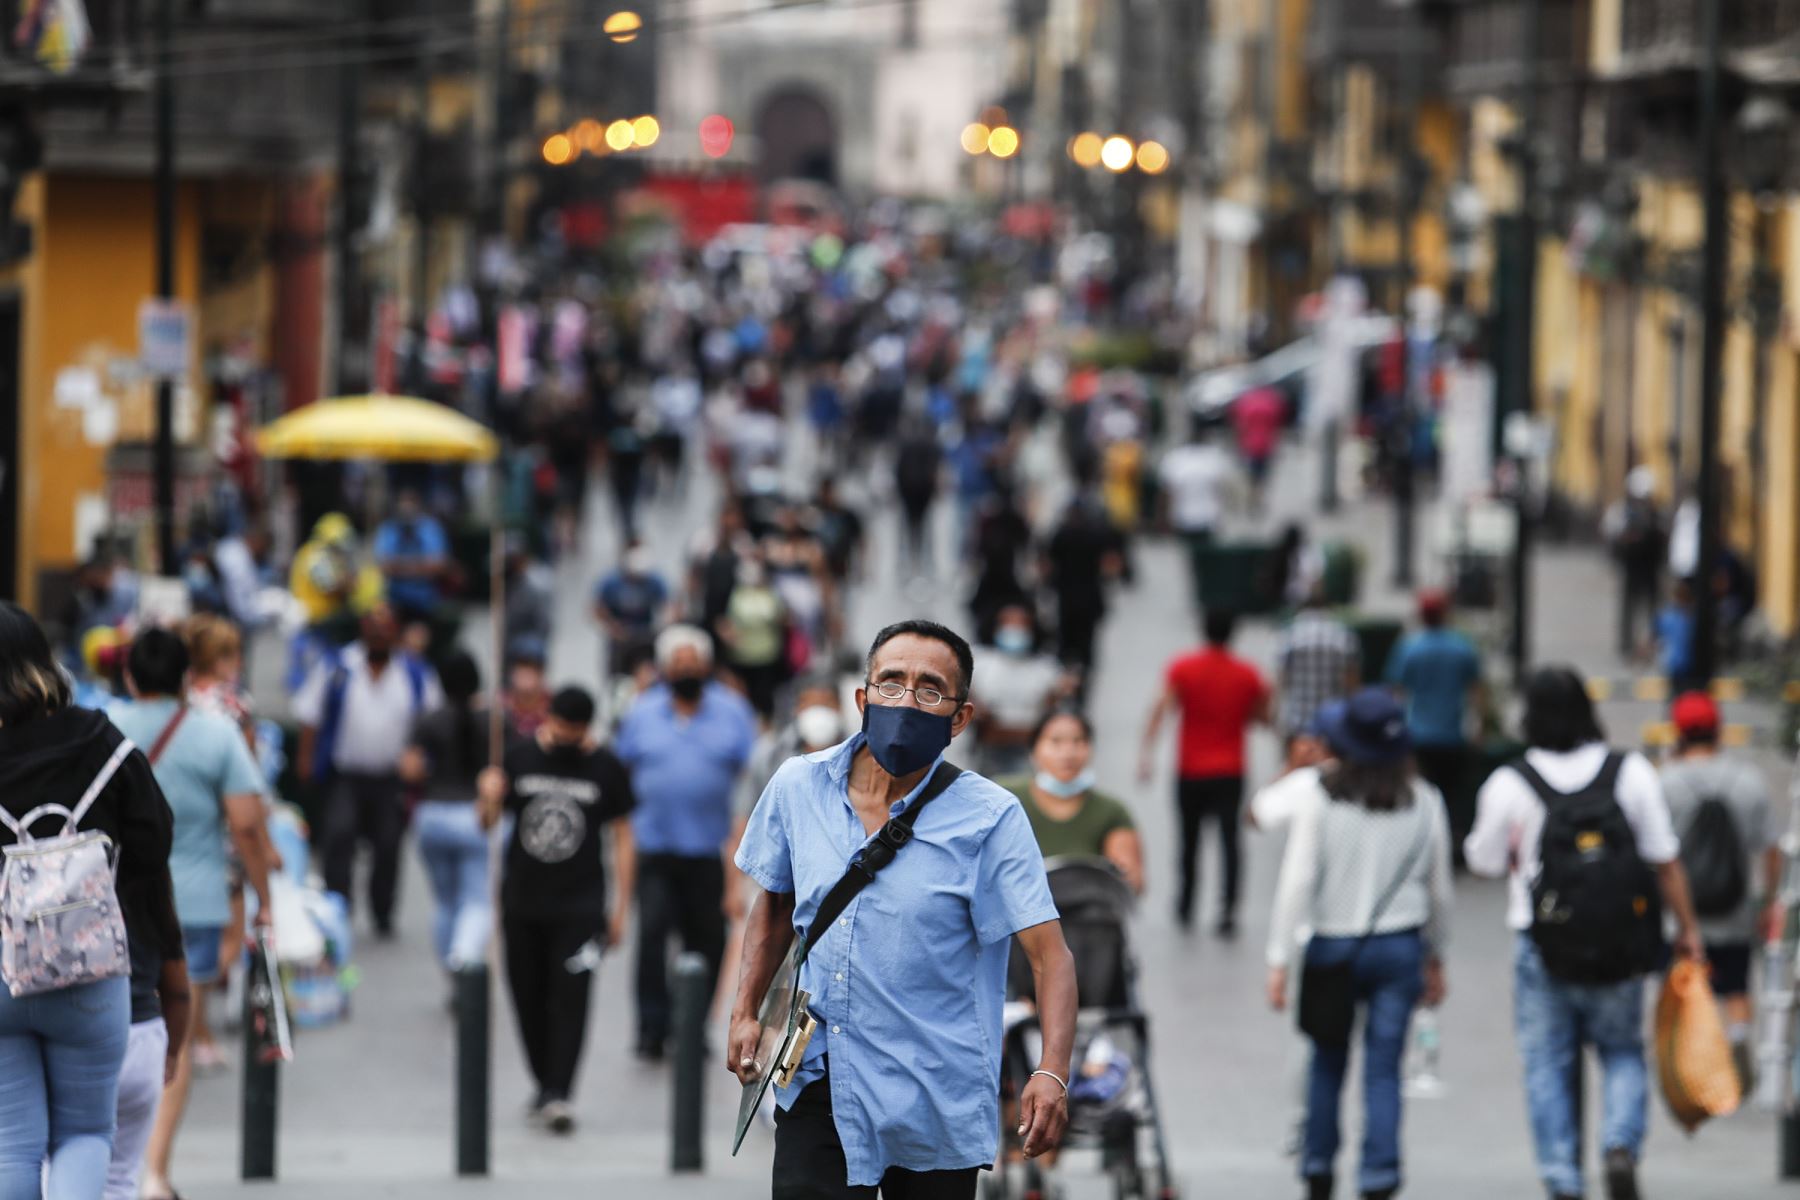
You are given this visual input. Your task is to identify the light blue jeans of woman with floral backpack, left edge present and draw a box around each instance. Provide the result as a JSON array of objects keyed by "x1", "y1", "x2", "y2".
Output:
[{"x1": 0, "y1": 977, "x2": 131, "y2": 1200}]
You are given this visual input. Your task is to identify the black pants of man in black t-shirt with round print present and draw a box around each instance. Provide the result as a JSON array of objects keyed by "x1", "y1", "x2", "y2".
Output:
[{"x1": 500, "y1": 914, "x2": 605, "y2": 1101}]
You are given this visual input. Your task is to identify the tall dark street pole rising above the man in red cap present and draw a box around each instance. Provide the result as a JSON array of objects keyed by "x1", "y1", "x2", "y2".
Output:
[{"x1": 1694, "y1": 0, "x2": 1732, "y2": 684}]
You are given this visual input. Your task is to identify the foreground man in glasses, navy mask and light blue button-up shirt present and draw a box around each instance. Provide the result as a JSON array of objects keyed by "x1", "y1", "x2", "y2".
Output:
[{"x1": 727, "y1": 621, "x2": 1076, "y2": 1200}]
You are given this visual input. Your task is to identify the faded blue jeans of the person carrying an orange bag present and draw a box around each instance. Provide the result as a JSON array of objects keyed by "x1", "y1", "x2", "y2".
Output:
[{"x1": 1512, "y1": 934, "x2": 1651, "y2": 1196}]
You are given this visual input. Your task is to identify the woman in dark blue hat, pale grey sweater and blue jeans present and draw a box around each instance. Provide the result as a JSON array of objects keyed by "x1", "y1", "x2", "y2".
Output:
[{"x1": 1269, "y1": 687, "x2": 1451, "y2": 1200}]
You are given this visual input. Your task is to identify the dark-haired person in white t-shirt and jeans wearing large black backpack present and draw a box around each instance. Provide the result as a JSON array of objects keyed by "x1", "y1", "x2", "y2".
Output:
[{"x1": 1463, "y1": 667, "x2": 1705, "y2": 1200}]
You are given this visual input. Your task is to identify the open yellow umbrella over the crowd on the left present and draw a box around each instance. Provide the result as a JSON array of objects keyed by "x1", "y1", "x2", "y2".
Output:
[{"x1": 256, "y1": 396, "x2": 500, "y2": 462}]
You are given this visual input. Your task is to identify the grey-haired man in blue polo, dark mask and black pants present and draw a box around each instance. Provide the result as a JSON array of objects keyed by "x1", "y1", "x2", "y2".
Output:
[{"x1": 612, "y1": 624, "x2": 756, "y2": 1061}]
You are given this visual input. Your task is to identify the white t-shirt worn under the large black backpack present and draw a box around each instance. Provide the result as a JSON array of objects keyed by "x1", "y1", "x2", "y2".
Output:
[{"x1": 1463, "y1": 741, "x2": 1681, "y2": 932}]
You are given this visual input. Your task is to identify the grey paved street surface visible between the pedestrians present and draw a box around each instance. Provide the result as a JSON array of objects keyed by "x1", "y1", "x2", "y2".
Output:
[{"x1": 176, "y1": 433, "x2": 1795, "y2": 1200}]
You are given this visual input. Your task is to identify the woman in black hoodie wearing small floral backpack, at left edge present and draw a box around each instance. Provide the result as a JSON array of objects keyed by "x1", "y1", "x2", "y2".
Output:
[{"x1": 0, "y1": 601, "x2": 182, "y2": 1198}]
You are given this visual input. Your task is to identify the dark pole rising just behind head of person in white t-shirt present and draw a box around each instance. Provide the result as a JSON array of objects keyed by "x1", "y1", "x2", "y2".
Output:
[{"x1": 1501, "y1": 0, "x2": 1544, "y2": 682}]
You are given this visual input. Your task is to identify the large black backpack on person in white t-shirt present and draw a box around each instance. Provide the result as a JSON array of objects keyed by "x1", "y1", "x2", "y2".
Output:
[{"x1": 1512, "y1": 754, "x2": 1663, "y2": 984}]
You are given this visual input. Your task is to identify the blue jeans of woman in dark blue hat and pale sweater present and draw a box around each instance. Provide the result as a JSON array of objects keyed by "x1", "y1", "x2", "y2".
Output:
[{"x1": 1300, "y1": 930, "x2": 1426, "y2": 1191}]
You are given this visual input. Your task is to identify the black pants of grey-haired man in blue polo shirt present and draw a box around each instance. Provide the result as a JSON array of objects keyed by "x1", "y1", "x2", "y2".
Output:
[{"x1": 637, "y1": 855, "x2": 725, "y2": 1045}]
